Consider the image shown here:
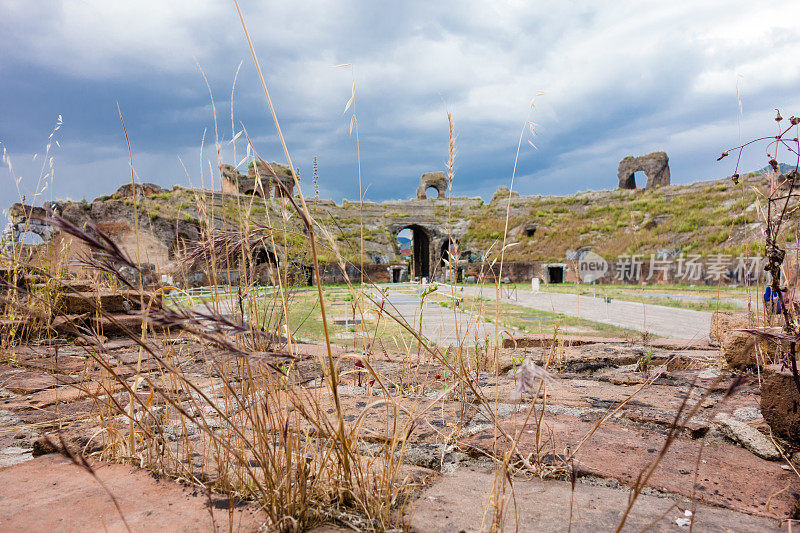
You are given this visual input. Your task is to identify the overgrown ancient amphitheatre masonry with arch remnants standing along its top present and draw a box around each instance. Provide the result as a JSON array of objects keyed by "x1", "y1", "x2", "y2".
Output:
[{"x1": 3, "y1": 152, "x2": 776, "y2": 285}]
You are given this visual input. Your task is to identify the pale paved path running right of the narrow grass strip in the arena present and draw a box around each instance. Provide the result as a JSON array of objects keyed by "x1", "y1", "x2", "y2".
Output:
[{"x1": 464, "y1": 286, "x2": 711, "y2": 340}]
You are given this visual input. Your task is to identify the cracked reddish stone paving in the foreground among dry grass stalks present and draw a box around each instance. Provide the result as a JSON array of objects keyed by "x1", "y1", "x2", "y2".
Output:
[{"x1": 0, "y1": 328, "x2": 800, "y2": 532}]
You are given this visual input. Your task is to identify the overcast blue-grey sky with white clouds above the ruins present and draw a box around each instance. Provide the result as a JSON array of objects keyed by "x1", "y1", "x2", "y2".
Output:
[{"x1": 0, "y1": 0, "x2": 800, "y2": 208}]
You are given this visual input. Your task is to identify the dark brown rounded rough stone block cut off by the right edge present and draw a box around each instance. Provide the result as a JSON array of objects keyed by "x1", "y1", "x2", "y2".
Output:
[{"x1": 761, "y1": 365, "x2": 800, "y2": 444}]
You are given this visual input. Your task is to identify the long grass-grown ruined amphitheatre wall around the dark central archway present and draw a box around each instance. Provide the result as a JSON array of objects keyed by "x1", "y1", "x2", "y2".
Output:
[{"x1": 4, "y1": 159, "x2": 763, "y2": 284}]
